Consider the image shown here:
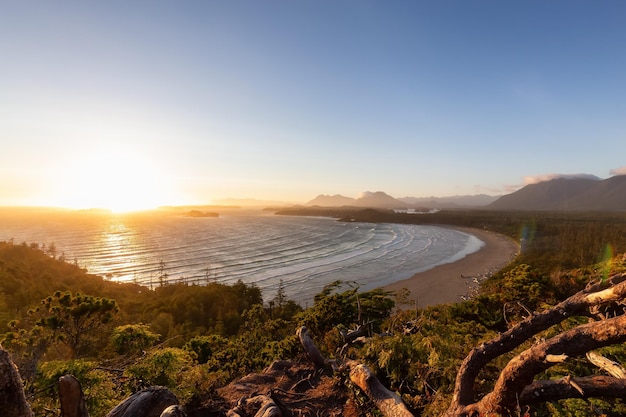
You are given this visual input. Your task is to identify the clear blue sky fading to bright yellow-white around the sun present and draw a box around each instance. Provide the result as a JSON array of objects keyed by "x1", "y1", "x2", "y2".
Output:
[{"x1": 0, "y1": 0, "x2": 626, "y2": 210}]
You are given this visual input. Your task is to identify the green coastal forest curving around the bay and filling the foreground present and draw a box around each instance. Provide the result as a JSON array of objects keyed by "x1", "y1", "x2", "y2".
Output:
[{"x1": 0, "y1": 209, "x2": 626, "y2": 417}]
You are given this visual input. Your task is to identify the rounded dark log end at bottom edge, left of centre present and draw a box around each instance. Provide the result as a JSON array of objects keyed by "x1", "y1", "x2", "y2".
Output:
[{"x1": 106, "y1": 387, "x2": 178, "y2": 417}]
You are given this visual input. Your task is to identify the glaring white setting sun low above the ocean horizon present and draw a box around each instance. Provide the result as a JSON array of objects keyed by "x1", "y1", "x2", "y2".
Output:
[{"x1": 61, "y1": 149, "x2": 170, "y2": 213}]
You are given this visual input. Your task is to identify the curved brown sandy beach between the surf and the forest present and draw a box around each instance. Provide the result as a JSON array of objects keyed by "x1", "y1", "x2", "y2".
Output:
[{"x1": 384, "y1": 227, "x2": 519, "y2": 308}]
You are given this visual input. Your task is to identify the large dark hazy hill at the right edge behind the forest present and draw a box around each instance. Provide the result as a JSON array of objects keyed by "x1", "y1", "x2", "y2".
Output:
[{"x1": 486, "y1": 175, "x2": 626, "y2": 211}]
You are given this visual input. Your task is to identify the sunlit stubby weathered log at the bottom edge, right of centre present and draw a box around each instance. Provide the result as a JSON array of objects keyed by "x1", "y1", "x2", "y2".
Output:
[{"x1": 347, "y1": 361, "x2": 413, "y2": 417}]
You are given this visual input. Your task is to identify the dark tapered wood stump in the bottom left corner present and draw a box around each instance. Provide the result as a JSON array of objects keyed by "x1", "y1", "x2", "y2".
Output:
[{"x1": 0, "y1": 345, "x2": 33, "y2": 417}]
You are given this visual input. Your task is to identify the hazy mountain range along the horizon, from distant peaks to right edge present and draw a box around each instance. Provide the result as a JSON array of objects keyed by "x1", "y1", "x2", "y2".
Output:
[{"x1": 306, "y1": 175, "x2": 626, "y2": 211}]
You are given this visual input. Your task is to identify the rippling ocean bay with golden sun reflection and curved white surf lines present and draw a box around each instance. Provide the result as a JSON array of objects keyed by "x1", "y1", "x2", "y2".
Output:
[{"x1": 0, "y1": 209, "x2": 484, "y2": 307}]
